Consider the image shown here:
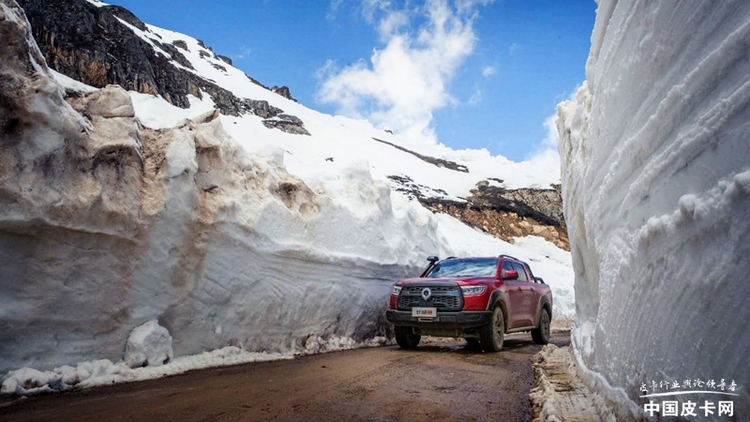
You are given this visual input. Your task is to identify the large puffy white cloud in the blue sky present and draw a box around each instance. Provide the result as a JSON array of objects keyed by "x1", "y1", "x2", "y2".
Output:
[{"x1": 317, "y1": 0, "x2": 493, "y2": 142}]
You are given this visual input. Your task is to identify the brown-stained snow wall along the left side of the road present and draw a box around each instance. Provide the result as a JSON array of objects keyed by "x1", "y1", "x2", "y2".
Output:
[{"x1": 0, "y1": 0, "x2": 428, "y2": 373}]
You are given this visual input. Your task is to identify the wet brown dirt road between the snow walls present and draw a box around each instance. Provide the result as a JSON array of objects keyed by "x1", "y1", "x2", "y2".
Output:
[{"x1": 0, "y1": 332, "x2": 570, "y2": 422}]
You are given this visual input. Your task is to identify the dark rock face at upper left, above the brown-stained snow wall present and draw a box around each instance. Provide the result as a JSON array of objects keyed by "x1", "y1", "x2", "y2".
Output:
[{"x1": 19, "y1": 0, "x2": 307, "y2": 133}]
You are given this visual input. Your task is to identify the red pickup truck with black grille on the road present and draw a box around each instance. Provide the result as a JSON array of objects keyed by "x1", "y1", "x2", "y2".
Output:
[{"x1": 386, "y1": 255, "x2": 552, "y2": 352}]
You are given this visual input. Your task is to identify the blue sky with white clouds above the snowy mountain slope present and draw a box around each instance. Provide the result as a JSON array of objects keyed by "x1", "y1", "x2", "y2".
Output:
[{"x1": 109, "y1": 0, "x2": 596, "y2": 161}]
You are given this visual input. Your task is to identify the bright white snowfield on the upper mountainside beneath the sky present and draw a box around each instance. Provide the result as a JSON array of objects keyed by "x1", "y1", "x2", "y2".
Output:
[{"x1": 123, "y1": 22, "x2": 560, "y2": 197}]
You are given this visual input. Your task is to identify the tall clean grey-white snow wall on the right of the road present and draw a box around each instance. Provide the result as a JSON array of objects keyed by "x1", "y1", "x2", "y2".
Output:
[{"x1": 558, "y1": 0, "x2": 750, "y2": 419}]
